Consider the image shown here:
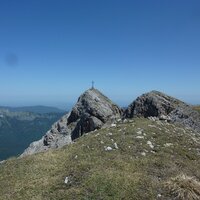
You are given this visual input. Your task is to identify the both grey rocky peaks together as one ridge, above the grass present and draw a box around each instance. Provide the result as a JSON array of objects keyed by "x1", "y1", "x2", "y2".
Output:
[{"x1": 21, "y1": 88, "x2": 200, "y2": 157}]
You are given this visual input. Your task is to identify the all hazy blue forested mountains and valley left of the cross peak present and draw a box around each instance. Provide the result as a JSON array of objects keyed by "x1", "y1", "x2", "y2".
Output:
[{"x1": 0, "y1": 106, "x2": 66, "y2": 160}]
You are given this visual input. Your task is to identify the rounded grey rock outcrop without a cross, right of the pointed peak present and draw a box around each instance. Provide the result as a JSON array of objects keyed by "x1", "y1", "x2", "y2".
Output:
[{"x1": 124, "y1": 91, "x2": 200, "y2": 131}]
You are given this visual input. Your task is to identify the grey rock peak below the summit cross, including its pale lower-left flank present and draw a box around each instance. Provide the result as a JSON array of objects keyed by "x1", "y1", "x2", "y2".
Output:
[{"x1": 21, "y1": 88, "x2": 122, "y2": 156}]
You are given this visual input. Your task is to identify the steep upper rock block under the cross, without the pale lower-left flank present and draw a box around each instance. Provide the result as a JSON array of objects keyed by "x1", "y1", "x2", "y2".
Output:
[{"x1": 68, "y1": 89, "x2": 122, "y2": 140}]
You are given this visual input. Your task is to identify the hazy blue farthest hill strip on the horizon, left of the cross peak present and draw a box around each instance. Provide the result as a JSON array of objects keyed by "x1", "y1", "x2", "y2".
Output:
[{"x1": 0, "y1": 105, "x2": 65, "y2": 114}]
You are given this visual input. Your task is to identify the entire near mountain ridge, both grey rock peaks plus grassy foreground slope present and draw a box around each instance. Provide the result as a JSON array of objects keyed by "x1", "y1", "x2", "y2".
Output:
[{"x1": 0, "y1": 89, "x2": 200, "y2": 200}]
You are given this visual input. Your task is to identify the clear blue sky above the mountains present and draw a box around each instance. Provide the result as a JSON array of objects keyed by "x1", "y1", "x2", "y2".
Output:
[{"x1": 0, "y1": 0, "x2": 200, "y2": 107}]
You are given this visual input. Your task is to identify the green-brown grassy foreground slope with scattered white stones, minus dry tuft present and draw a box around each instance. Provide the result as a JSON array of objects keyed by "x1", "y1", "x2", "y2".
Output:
[{"x1": 0, "y1": 119, "x2": 200, "y2": 200}]
